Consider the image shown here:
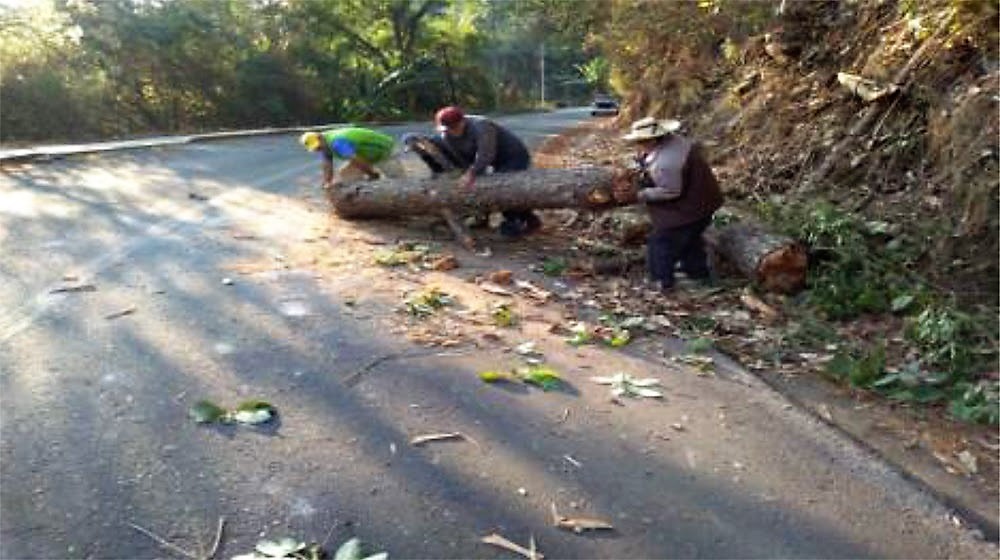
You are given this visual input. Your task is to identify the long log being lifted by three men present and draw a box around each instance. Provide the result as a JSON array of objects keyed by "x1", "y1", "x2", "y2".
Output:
[{"x1": 328, "y1": 167, "x2": 630, "y2": 219}]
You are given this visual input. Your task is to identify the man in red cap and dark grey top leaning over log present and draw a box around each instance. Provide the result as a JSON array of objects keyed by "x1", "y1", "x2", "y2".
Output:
[{"x1": 434, "y1": 106, "x2": 542, "y2": 237}]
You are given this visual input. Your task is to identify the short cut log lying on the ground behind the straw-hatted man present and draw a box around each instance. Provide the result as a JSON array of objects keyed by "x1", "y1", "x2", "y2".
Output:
[{"x1": 709, "y1": 224, "x2": 808, "y2": 294}]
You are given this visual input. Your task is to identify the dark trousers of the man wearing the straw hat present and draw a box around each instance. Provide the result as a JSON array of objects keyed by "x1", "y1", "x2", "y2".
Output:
[{"x1": 646, "y1": 216, "x2": 712, "y2": 287}]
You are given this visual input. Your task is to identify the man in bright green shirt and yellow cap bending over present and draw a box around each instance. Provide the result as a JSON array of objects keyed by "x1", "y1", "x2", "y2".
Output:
[{"x1": 299, "y1": 126, "x2": 403, "y2": 189}]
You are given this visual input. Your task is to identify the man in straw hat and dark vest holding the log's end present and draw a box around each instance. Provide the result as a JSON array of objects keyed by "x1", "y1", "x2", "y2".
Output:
[{"x1": 615, "y1": 117, "x2": 722, "y2": 292}]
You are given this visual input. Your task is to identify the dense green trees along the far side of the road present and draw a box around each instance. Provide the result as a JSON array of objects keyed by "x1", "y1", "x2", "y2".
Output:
[{"x1": 0, "y1": 0, "x2": 607, "y2": 141}]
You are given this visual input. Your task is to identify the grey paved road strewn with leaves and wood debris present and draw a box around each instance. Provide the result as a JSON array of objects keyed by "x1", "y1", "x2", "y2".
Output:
[{"x1": 0, "y1": 110, "x2": 996, "y2": 558}]
